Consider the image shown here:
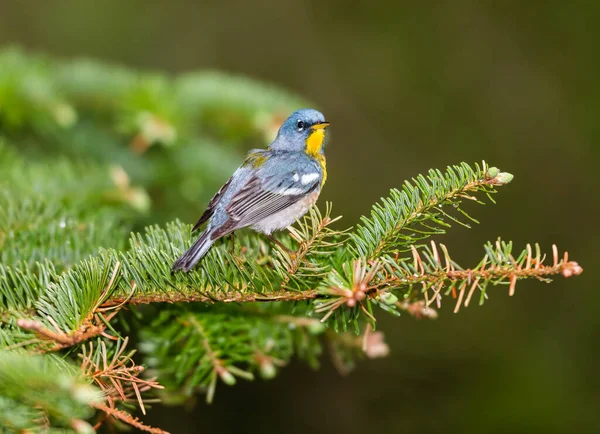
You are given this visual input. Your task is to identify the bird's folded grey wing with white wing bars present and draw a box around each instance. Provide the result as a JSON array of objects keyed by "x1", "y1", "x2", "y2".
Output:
[{"x1": 213, "y1": 165, "x2": 321, "y2": 238}]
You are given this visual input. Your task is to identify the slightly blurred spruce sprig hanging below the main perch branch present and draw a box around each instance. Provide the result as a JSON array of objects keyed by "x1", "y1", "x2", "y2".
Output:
[{"x1": 141, "y1": 304, "x2": 325, "y2": 402}]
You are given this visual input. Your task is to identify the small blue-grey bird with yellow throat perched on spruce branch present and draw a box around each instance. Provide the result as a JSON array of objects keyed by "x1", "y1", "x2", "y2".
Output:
[{"x1": 171, "y1": 108, "x2": 330, "y2": 272}]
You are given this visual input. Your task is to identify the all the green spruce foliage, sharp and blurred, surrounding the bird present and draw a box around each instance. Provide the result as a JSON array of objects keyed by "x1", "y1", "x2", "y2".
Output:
[{"x1": 0, "y1": 49, "x2": 582, "y2": 432}]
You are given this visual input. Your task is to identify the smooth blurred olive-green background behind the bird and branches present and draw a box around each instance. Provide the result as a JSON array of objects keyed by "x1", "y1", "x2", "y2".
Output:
[{"x1": 0, "y1": 0, "x2": 600, "y2": 434}]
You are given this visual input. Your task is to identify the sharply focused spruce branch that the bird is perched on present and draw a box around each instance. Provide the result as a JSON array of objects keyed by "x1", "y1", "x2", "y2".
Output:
[{"x1": 0, "y1": 165, "x2": 579, "y2": 347}]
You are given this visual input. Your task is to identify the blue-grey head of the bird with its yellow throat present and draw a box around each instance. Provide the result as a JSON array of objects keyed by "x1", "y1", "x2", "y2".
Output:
[{"x1": 270, "y1": 109, "x2": 329, "y2": 157}]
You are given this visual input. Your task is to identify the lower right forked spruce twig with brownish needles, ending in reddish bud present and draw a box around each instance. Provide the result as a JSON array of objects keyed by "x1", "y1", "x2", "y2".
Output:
[{"x1": 315, "y1": 240, "x2": 583, "y2": 330}]
